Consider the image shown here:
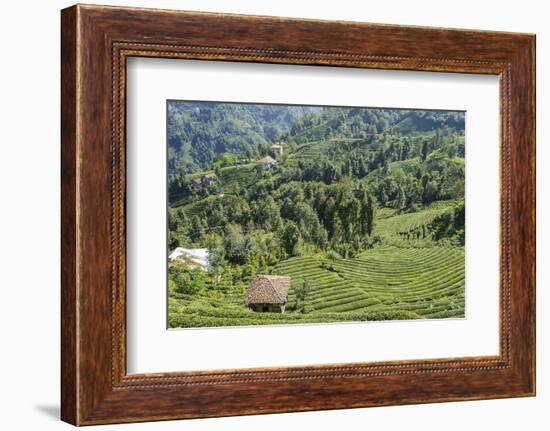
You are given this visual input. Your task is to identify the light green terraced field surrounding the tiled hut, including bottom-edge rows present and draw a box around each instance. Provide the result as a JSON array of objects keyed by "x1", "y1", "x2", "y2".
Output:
[{"x1": 170, "y1": 246, "x2": 465, "y2": 327}]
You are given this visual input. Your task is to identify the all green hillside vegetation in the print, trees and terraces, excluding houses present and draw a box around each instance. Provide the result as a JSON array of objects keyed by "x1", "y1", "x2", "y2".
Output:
[{"x1": 168, "y1": 102, "x2": 465, "y2": 327}]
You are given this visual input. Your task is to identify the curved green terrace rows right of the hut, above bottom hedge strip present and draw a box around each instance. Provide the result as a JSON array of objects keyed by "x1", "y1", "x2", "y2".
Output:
[{"x1": 275, "y1": 246, "x2": 464, "y2": 317}]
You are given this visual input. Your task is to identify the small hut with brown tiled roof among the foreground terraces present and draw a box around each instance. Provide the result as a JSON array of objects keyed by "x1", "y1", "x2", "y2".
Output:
[{"x1": 246, "y1": 275, "x2": 290, "y2": 313}]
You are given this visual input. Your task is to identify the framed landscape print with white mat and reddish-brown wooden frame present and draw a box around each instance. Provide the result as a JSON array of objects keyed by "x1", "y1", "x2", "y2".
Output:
[{"x1": 61, "y1": 5, "x2": 535, "y2": 425}]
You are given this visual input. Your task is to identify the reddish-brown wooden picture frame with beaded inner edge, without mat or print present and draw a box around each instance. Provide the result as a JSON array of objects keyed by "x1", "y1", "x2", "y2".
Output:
[{"x1": 61, "y1": 5, "x2": 535, "y2": 425}]
